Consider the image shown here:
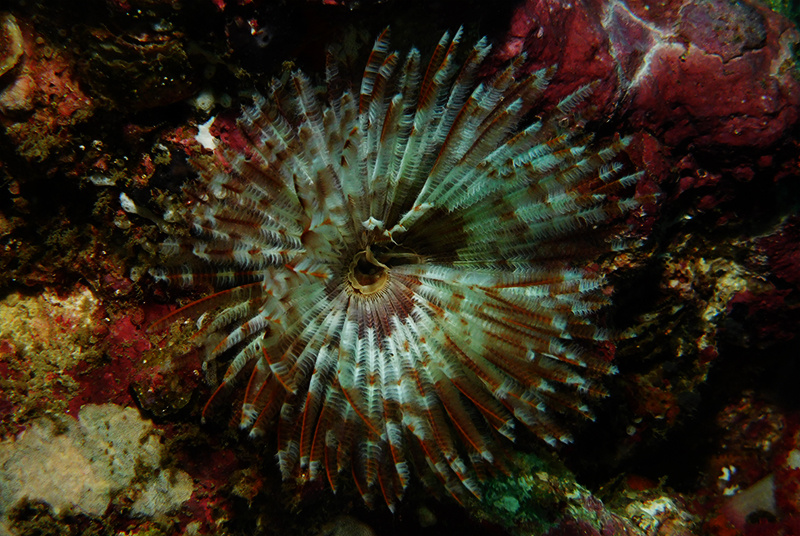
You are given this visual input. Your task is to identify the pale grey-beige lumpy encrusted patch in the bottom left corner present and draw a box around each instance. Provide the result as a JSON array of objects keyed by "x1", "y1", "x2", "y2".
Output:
[{"x1": 0, "y1": 404, "x2": 194, "y2": 523}]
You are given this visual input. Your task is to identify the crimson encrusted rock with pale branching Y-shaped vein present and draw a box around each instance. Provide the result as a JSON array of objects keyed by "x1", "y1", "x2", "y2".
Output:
[{"x1": 500, "y1": 0, "x2": 800, "y2": 147}]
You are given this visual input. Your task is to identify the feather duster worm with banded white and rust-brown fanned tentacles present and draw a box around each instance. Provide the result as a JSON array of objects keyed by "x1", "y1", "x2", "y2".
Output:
[{"x1": 121, "y1": 29, "x2": 642, "y2": 510}]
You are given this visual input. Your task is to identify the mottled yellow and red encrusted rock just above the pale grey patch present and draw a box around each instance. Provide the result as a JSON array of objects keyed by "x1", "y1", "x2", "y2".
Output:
[{"x1": 0, "y1": 274, "x2": 208, "y2": 436}]
